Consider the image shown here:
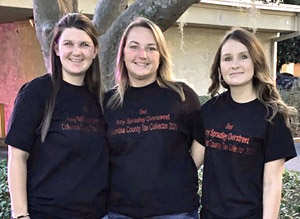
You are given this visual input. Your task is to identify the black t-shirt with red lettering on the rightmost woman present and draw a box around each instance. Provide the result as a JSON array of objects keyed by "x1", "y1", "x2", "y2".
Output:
[{"x1": 196, "y1": 91, "x2": 296, "y2": 219}]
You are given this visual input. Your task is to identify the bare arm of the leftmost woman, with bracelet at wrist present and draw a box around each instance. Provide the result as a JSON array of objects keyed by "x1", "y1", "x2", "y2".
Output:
[{"x1": 8, "y1": 146, "x2": 29, "y2": 219}]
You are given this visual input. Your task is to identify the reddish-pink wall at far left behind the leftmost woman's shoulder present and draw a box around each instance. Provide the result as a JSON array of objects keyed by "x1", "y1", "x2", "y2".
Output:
[{"x1": 0, "y1": 21, "x2": 45, "y2": 131}]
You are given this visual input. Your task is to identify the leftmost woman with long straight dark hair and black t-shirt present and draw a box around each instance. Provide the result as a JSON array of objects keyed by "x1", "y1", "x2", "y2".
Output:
[{"x1": 5, "y1": 13, "x2": 108, "y2": 219}]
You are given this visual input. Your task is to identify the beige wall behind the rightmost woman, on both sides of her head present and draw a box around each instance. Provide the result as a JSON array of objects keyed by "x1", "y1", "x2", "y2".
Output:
[{"x1": 165, "y1": 26, "x2": 276, "y2": 95}]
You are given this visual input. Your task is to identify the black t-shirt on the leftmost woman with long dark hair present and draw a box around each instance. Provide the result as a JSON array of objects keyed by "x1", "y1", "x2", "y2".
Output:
[{"x1": 5, "y1": 75, "x2": 109, "y2": 219}]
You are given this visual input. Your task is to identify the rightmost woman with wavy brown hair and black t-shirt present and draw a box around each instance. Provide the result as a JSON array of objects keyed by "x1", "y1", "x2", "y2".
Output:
[{"x1": 193, "y1": 28, "x2": 296, "y2": 219}]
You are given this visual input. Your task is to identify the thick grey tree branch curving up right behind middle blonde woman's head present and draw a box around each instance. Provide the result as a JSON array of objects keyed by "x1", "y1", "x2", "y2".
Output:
[{"x1": 95, "y1": 0, "x2": 199, "y2": 87}]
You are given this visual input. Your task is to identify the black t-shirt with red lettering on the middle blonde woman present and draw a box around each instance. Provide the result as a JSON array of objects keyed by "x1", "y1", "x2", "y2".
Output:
[{"x1": 104, "y1": 82, "x2": 200, "y2": 218}]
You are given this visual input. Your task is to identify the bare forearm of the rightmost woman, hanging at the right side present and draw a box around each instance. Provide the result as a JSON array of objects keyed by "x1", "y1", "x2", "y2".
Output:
[{"x1": 263, "y1": 159, "x2": 285, "y2": 219}]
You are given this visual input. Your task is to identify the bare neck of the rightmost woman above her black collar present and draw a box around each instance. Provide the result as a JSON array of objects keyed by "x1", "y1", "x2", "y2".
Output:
[{"x1": 230, "y1": 86, "x2": 257, "y2": 103}]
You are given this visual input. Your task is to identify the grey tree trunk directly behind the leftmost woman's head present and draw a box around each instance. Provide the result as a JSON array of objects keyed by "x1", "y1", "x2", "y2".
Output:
[{"x1": 33, "y1": 0, "x2": 78, "y2": 72}]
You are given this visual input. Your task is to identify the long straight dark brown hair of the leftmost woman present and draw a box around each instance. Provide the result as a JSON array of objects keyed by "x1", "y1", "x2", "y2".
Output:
[{"x1": 40, "y1": 13, "x2": 103, "y2": 142}]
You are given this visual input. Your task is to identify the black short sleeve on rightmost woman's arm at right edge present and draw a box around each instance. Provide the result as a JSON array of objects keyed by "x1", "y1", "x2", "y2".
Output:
[{"x1": 265, "y1": 113, "x2": 297, "y2": 163}]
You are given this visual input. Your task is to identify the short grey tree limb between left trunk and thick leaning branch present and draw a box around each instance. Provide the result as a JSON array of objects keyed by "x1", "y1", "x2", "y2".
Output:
[{"x1": 93, "y1": 0, "x2": 128, "y2": 35}]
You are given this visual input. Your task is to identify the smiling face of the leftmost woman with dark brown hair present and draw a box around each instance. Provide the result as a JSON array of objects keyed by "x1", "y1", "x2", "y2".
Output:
[{"x1": 55, "y1": 28, "x2": 98, "y2": 85}]
